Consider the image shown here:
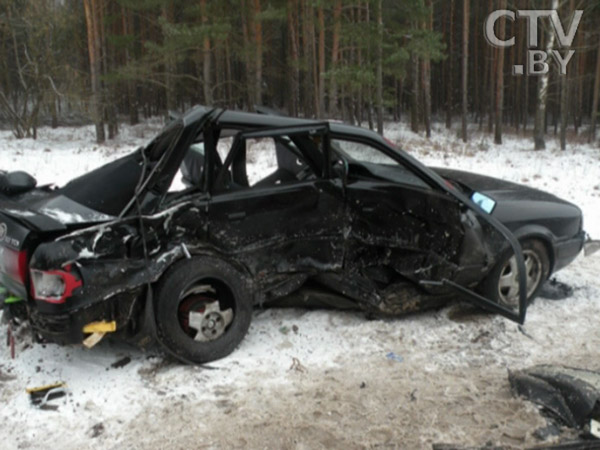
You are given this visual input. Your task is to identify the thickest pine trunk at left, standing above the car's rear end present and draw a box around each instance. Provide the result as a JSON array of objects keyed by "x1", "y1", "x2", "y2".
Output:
[{"x1": 83, "y1": 0, "x2": 106, "y2": 143}]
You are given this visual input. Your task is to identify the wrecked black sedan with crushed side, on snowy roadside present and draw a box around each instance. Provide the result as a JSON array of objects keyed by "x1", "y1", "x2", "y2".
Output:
[{"x1": 0, "y1": 107, "x2": 597, "y2": 363}]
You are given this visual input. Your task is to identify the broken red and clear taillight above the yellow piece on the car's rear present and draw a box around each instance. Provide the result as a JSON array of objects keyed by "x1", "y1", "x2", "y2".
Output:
[{"x1": 29, "y1": 266, "x2": 82, "y2": 303}]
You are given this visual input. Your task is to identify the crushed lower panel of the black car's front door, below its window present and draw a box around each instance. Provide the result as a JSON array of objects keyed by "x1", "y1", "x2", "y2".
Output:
[{"x1": 347, "y1": 181, "x2": 464, "y2": 280}]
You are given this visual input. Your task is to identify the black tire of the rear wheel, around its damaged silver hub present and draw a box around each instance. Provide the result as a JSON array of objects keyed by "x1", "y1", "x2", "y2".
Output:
[{"x1": 155, "y1": 256, "x2": 253, "y2": 364}]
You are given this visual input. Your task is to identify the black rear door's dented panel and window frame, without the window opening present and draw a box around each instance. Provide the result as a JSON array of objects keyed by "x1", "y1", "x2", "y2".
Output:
[{"x1": 208, "y1": 124, "x2": 347, "y2": 277}]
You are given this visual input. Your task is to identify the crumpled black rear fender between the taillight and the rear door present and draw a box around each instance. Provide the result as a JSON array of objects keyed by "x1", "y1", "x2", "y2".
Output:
[{"x1": 30, "y1": 202, "x2": 207, "y2": 311}]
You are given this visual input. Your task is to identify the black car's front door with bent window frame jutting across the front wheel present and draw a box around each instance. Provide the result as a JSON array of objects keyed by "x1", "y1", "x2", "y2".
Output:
[{"x1": 331, "y1": 135, "x2": 527, "y2": 323}]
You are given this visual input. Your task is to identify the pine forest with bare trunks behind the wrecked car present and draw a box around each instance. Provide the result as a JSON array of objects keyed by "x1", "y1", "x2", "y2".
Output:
[{"x1": 0, "y1": 0, "x2": 600, "y2": 149}]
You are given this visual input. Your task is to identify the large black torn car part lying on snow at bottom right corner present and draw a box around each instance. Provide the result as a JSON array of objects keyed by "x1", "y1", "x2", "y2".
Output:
[{"x1": 508, "y1": 365, "x2": 600, "y2": 437}]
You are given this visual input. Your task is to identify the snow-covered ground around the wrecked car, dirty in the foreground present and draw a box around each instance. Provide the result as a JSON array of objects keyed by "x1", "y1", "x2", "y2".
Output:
[{"x1": 0, "y1": 122, "x2": 600, "y2": 449}]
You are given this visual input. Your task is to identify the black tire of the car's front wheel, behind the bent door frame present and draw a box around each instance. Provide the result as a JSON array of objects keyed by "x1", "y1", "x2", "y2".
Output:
[{"x1": 481, "y1": 239, "x2": 550, "y2": 308}]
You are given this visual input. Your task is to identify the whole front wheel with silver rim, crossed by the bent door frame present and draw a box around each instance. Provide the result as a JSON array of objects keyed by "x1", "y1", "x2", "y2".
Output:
[{"x1": 483, "y1": 239, "x2": 550, "y2": 308}]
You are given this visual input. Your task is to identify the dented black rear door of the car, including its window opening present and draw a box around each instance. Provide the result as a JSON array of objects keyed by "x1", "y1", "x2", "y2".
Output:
[{"x1": 208, "y1": 124, "x2": 345, "y2": 278}]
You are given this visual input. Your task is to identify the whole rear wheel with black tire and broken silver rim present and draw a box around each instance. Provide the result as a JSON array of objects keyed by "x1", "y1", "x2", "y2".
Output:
[{"x1": 156, "y1": 256, "x2": 252, "y2": 364}]
